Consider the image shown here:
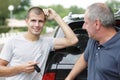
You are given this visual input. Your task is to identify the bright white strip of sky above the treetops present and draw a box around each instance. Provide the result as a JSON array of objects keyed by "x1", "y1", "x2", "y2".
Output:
[{"x1": 31, "y1": 0, "x2": 106, "y2": 9}]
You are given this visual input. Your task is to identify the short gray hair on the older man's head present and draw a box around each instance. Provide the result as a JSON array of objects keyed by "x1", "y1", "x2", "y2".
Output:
[{"x1": 87, "y1": 3, "x2": 115, "y2": 27}]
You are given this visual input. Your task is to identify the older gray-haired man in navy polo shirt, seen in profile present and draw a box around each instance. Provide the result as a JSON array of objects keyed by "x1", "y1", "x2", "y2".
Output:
[{"x1": 65, "y1": 3, "x2": 120, "y2": 80}]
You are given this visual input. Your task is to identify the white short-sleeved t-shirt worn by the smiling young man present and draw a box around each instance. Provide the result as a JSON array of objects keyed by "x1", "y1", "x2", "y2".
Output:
[{"x1": 0, "y1": 35, "x2": 54, "y2": 80}]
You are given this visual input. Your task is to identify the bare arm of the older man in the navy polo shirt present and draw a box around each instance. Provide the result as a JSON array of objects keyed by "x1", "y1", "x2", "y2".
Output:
[{"x1": 65, "y1": 54, "x2": 87, "y2": 80}]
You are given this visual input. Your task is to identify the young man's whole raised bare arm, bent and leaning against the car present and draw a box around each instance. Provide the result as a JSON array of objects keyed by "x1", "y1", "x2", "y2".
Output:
[{"x1": 45, "y1": 9, "x2": 78, "y2": 49}]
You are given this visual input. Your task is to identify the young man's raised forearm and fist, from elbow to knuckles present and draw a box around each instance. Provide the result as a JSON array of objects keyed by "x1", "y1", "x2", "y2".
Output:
[{"x1": 44, "y1": 8, "x2": 78, "y2": 42}]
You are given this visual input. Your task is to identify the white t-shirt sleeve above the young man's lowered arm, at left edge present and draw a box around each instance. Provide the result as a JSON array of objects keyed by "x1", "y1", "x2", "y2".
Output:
[{"x1": 0, "y1": 38, "x2": 13, "y2": 62}]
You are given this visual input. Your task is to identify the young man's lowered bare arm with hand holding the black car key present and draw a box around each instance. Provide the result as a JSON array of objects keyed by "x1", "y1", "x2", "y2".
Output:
[{"x1": 0, "y1": 59, "x2": 37, "y2": 77}]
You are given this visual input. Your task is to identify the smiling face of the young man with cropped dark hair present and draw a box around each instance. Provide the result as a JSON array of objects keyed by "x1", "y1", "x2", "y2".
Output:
[{"x1": 26, "y1": 12, "x2": 45, "y2": 35}]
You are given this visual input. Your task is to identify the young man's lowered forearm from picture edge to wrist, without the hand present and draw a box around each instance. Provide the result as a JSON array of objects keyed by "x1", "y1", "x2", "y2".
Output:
[{"x1": 0, "y1": 66, "x2": 22, "y2": 77}]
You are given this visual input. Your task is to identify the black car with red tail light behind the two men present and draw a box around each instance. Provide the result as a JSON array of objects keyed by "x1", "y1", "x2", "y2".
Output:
[{"x1": 43, "y1": 10, "x2": 120, "y2": 80}]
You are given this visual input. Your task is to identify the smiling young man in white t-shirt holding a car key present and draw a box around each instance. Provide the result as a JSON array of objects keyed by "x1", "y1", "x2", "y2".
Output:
[{"x1": 0, "y1": 7, "x2": 78, "y2": 80}]
